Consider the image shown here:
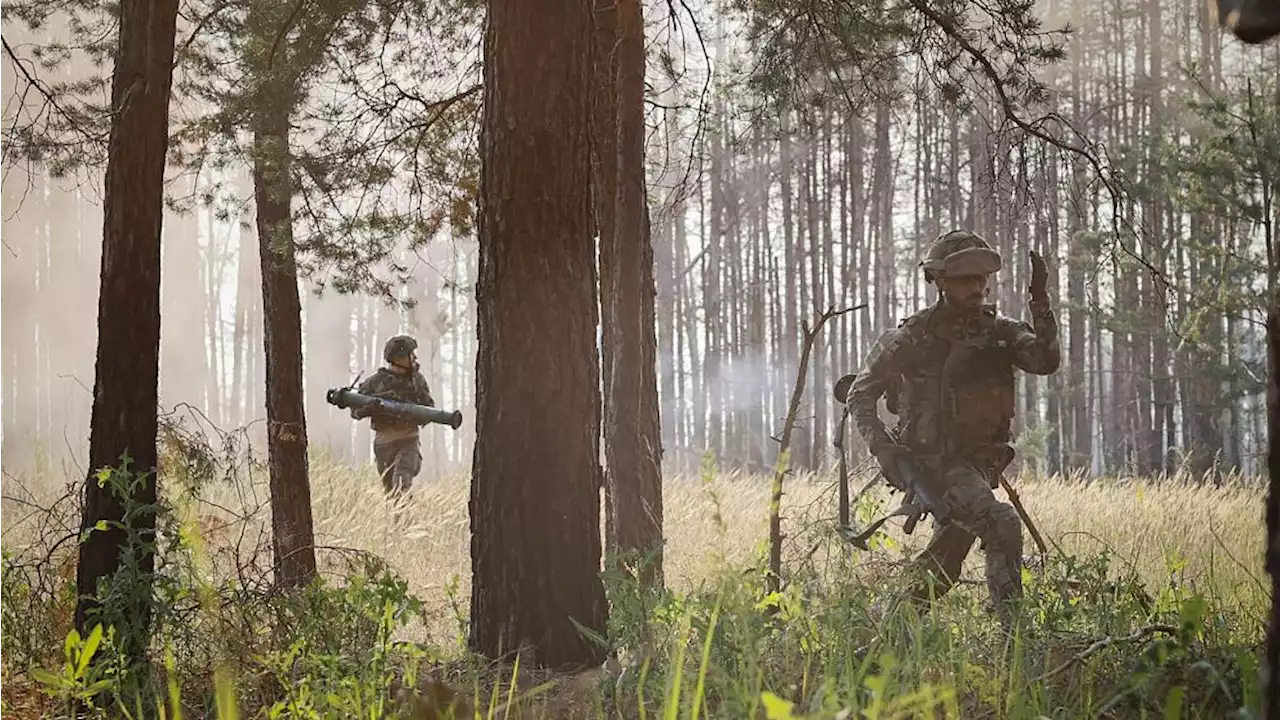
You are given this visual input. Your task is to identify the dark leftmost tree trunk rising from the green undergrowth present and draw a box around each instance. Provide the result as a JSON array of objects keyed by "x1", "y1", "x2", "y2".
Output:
[{"x1": 76, "y1": 0, "x2": 178, "y2": 661}]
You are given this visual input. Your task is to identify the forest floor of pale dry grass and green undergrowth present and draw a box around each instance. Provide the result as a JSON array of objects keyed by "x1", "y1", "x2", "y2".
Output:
[{"x1": 0, "y1": 448, "x2": 1270, "y2": 717}]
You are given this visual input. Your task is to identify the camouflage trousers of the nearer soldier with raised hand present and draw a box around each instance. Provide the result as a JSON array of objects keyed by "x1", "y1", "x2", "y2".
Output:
[{"x1": 911, "y1": 462, "x2": 1023, "y2": 621}]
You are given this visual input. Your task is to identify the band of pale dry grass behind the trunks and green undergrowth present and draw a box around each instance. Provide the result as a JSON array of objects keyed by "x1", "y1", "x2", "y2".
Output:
[{"x1": 0, "y1": 457, "x2": 1267, "y2": 634}]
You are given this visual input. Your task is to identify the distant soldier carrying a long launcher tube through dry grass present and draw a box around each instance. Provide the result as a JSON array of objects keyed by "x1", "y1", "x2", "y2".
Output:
[{"x1": 351, "y1": 336, "x2": 435, "y2": 498}]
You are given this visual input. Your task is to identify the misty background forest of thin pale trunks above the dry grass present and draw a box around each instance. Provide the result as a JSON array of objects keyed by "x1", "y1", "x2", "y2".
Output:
[{"x1": 0, "y1": 0, "x2": 1280, "y2": 479}]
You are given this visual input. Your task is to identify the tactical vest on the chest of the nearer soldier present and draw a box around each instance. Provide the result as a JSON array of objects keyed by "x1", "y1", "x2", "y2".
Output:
[{"x1": 886, "y1": 306, "x2": 1016, "y2": 468}]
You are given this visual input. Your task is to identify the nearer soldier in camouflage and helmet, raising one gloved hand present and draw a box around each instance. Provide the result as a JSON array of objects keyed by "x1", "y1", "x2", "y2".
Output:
[{"x1": 849, "y1": 231, "x2": 1061, "y2": 624}]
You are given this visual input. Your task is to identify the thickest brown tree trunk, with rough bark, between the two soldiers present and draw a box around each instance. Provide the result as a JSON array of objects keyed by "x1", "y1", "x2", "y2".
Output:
[{"x1": 470, "y1": 0, "x2": 608, "y2": 669}]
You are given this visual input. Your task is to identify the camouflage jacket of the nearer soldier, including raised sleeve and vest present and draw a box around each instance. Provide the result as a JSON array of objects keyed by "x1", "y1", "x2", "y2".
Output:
[{"x1": 849, "y1": 302, "x2": 1061, "y2": 462}]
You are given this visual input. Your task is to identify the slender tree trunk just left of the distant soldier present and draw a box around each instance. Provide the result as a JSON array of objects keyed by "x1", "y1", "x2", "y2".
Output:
[{"x1": 253, "y1": 85, "x2": 316, "y2": 588}]
